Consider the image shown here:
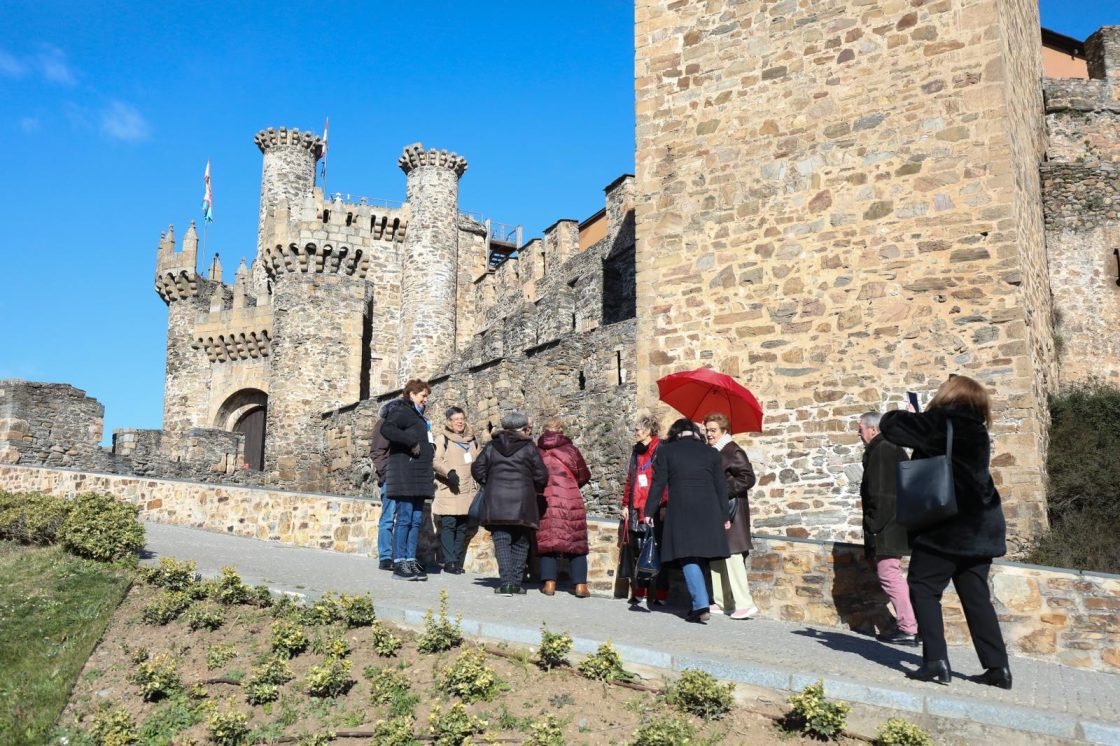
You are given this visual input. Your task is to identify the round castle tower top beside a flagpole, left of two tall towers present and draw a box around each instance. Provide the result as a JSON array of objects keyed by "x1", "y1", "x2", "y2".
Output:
[{"x1": 253, "y1": 127, "x2": 323, "y2": 257}]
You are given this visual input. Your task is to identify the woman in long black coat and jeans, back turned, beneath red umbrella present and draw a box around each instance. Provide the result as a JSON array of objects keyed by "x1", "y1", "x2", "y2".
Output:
[{"x1": 645, "y1": 418, "x2": 731, "y2": 623}]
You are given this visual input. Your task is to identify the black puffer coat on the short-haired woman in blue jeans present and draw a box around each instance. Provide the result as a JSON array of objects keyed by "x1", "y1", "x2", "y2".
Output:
[{"x1": 381, "y1": 398, "x2": 436, "y2": 498}]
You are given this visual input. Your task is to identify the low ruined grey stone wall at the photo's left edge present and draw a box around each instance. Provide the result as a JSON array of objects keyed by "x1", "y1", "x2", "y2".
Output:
[{"x1": 0, "y1": 379, "x2": 109, "y2": 468}]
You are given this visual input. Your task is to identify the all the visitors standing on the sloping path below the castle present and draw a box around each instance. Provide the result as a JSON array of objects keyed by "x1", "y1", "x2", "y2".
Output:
[{"x1": 372, "y1": 375, "x2": 1011, "y2": 689}]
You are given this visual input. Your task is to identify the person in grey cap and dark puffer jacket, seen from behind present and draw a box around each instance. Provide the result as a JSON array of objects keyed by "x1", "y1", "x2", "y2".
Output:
[{"x1": 470, "y1": 411, "x2": 549, "y2": 596}]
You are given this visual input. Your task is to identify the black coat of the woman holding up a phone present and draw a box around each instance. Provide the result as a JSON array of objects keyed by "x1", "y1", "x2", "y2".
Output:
[{"x1": 879, "y1": 407, "x2": 1007, "y2": 558}]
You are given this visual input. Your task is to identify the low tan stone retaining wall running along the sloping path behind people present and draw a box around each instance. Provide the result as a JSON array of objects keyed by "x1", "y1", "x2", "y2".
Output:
[{"x1": 0, "y1": 466, "x2": 1120, "y2": 673}]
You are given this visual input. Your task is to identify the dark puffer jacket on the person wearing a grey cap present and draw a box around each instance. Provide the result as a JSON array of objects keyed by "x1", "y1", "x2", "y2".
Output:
[{"x1": 470, "y1": 430, "x2": 549, "y2": 529}]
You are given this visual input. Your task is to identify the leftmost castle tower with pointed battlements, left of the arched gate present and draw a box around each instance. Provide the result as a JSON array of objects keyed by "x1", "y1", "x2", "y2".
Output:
[{"x1": 156, "y1": 222, "x2": 211, "y2": 449}]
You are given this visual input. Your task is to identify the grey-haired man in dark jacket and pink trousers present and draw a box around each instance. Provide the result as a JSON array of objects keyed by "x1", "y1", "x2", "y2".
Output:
[{"x1": 859, "y1": 412, "x2": 917, "y2": 647}]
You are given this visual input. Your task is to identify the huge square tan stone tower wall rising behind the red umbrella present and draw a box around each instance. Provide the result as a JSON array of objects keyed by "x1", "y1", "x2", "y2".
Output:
[{"x1": 635, "y1": 0, "x2": 1054, "y2": 548}]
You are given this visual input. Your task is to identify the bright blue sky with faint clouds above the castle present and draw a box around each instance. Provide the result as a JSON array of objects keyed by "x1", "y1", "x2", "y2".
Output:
[{"x1": 0, "y1": 0, "x2": 1120, "y2": 441}]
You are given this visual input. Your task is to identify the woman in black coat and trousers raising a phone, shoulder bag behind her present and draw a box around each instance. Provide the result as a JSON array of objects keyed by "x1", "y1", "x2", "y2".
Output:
[{"x1": 879, "y1": 375, "x2": 1011, "y2": 689}]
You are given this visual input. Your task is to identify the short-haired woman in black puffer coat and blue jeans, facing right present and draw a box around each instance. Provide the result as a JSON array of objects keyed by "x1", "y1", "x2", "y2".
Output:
[{"x1": 381, "y1": 379, "x2": 436, "y2": 580}]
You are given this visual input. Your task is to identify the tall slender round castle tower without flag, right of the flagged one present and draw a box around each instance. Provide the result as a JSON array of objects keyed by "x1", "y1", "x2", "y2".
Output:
[{"x1": 398, "y1": 142, "x2": 467, "y2": 383}]
